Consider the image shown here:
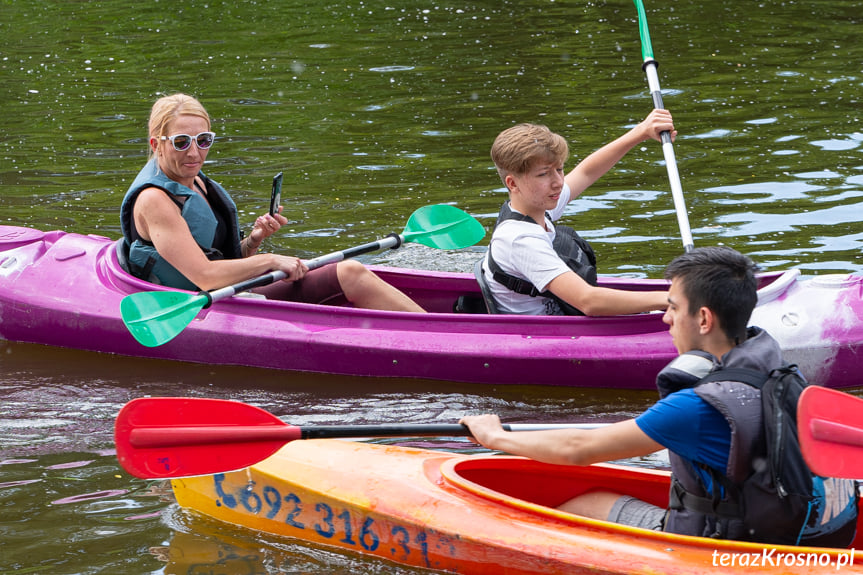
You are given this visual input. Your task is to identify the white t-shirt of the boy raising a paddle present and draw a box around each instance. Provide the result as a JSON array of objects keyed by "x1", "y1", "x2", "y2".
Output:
[{"x1": 482, "y1": 184, "x2": 571, "y2": 315}]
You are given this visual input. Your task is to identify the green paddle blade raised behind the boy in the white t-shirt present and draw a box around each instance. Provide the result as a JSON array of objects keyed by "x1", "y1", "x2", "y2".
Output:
[{"x1": 402, "y1": 204, "x2": 485, "y2": 250}]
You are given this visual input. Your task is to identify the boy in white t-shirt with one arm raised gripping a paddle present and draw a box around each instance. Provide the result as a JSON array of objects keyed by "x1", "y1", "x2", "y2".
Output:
[{"x1": 483, "y1": 110, "x2": 677, "y2": 316}]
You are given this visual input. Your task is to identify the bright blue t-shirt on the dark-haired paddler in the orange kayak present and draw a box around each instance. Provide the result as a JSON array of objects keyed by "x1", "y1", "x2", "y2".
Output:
[{"x1": 635, "y1": 389, "x2": 731, "y2": 476}]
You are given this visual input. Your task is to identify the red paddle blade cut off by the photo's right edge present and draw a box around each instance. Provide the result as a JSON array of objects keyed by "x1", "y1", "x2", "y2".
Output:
[{"x1": 797, "y1": 385, "x2": 863, "y2": 479}]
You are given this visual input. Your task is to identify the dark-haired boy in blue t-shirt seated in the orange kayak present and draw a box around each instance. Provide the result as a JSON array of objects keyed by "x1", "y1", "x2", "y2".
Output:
[{"x1": 462, "y1": 247, "x2": 857, "y2": 547}]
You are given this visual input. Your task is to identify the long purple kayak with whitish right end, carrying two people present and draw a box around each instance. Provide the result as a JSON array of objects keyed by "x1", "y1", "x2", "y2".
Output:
[{"x1": 0, "y1": 226, "x2": 863, "y2": 389}]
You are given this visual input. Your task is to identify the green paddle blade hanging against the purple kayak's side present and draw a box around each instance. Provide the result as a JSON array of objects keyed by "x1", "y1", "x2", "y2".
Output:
[{"x1": 120, "y1": 291, "x2": 209, "y2": 347}]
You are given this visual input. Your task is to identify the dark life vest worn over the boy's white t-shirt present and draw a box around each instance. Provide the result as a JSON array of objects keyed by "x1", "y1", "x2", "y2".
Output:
[{"x1": 488, "y1": 201, "x2": 597, "y2": 315}]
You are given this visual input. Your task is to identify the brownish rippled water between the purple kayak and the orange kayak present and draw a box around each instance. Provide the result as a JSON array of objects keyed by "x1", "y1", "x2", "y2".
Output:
[{"x1": 0, "y1": 344, "x2": 653, "y2": 574}]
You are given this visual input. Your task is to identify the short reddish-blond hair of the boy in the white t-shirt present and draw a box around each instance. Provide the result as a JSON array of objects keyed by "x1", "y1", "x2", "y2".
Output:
[{"x1": 491, "y1": 124, "x2": 569, "y2": 189}]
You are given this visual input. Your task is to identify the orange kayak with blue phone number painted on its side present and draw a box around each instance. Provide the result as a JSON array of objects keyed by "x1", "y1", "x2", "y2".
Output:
[{"x1": 172, "y1": 439, "x2": 863, "y2": 575}]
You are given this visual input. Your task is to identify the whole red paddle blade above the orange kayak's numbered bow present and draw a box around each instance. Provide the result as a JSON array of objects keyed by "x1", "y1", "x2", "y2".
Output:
[{"x1": 114, "y1": 397, "x2": 301, "y2": 479}]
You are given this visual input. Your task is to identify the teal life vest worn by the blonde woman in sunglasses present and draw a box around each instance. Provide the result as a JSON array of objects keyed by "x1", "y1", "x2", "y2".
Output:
[{"x1": 120, "y1": 159, "x2": 242, "y2": 291}]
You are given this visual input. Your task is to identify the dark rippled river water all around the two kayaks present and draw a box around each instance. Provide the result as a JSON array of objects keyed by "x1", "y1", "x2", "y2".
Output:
[{"x1": 0, "y1": 0, "x2": 863, "y2": 574}]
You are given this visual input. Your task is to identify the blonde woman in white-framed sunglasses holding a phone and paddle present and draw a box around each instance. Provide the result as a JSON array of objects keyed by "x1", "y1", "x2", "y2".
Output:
[{"x1": 120, "y1": 94, "x2": 423, "y2": 312}]
